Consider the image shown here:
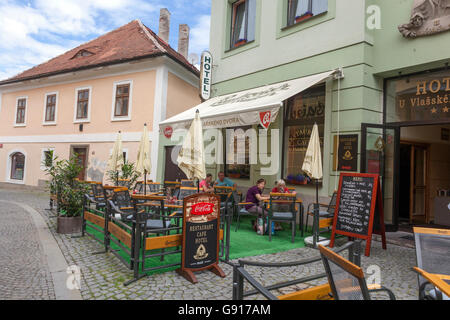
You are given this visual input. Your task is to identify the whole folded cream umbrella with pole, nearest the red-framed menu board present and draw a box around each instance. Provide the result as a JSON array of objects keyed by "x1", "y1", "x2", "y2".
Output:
[{"x1": 302, "y1": 123, "x2": 323, "y2": 247}]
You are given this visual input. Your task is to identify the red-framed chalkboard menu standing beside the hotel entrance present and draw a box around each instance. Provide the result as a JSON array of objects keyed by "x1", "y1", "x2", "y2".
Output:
[{"x1": 330, "y1": 173, "x2": 386, "y2": 256}]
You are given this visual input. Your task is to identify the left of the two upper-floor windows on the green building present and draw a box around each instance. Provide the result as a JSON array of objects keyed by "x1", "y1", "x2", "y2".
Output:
[{"x1": 230, "y1": 0, "x2": 256, "y2": 48}]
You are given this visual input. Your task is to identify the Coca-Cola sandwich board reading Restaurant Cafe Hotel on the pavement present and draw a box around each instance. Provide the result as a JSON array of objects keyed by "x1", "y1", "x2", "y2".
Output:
[{"x1": 177, "y1": 193, "x2": 225, "y2": 283}]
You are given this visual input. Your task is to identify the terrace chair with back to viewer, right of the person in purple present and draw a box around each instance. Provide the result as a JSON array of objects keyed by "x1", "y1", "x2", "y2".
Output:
[{"x1": 267, "y1": 193, "x2": 297, "y2": 243}]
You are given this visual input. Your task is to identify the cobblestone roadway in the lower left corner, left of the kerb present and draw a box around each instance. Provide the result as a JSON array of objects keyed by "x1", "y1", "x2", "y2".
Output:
[{"x1": 0, "y1": 193, "x2": 55, "y2": 300}]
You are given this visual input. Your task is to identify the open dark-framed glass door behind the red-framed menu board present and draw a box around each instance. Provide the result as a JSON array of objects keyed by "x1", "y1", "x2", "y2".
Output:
[{"x1": 360, "y1": 123, "x2": 400, "y2": 231}]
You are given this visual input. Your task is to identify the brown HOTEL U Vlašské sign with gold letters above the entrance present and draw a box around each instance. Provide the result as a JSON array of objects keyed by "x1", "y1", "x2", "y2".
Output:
[{"x1": 396, "y1": 76, "x2": 450, "y2": 121}]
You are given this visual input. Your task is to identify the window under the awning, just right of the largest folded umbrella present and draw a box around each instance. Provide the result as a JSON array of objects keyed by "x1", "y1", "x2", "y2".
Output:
[{"x1": 225, "y1": 126, "x2": 256, "y2": 179}]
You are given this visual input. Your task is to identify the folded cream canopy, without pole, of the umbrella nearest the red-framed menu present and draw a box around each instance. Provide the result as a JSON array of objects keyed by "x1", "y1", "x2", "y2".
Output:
[{"x1": 302, "y1": 123, "x2": 323, "y2": 180}]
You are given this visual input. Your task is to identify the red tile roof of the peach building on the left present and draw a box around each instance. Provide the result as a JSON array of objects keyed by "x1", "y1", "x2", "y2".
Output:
[{"x1": 0, "y1": 20, "x2": 199, "y2": 85}]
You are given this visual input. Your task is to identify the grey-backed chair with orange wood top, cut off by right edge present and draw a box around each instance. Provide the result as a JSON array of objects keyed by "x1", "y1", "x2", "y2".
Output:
[{"x1": 413, "y1": 227, "x2": 450, "y2": 300}]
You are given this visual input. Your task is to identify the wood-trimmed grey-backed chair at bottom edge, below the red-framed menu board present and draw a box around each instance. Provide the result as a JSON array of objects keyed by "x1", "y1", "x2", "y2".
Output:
[{"x1": 319, "y1": 245, "x2": 395, "y2": 300}]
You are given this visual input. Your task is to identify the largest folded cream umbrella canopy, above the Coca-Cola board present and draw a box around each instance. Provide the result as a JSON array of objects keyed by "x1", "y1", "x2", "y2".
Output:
[{"x1": 177, "y1": 110, "x2": 206, "y2": 180}]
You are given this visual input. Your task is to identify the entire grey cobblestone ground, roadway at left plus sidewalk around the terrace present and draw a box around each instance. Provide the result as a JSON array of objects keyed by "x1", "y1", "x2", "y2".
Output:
[{"x1": 0, "y1": 189, "x2": 417, "y2": 300}]
